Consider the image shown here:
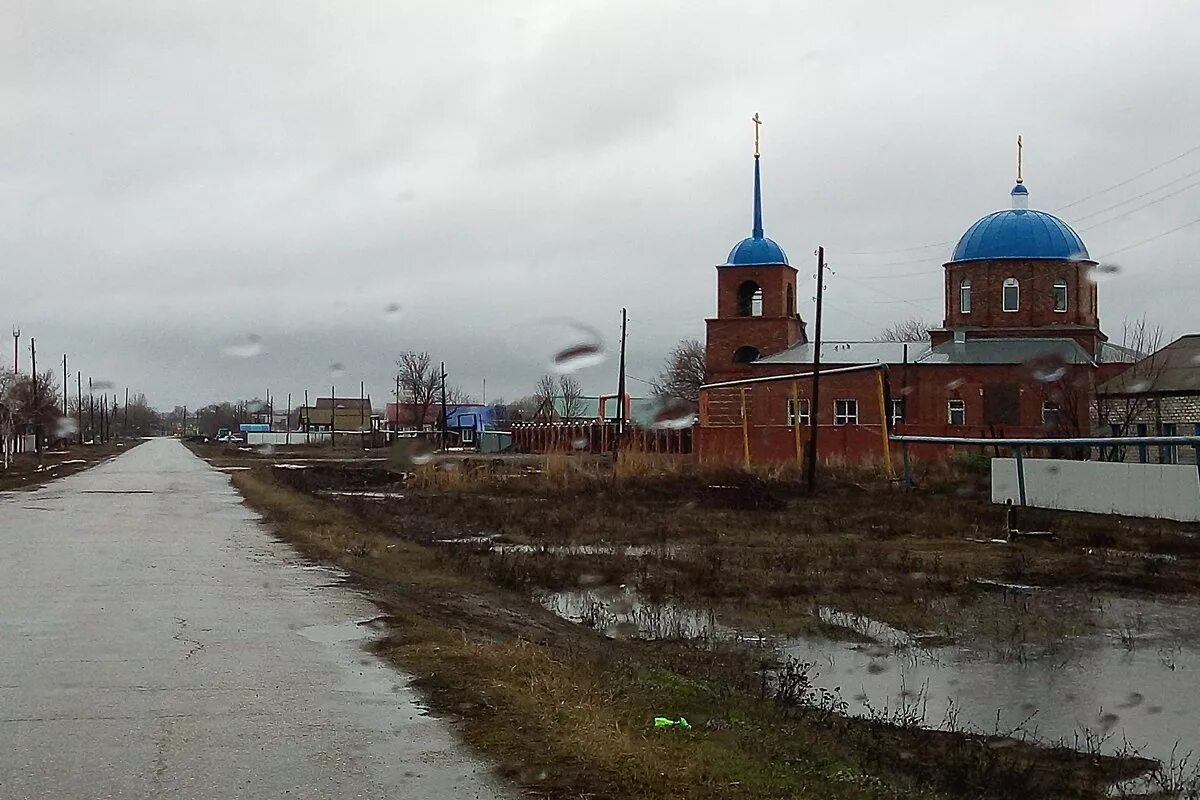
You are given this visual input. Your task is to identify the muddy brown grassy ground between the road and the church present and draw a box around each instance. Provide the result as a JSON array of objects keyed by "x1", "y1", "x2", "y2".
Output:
[{"x1": 197, "y1": 447, "x2": 1200, "y2": 798}]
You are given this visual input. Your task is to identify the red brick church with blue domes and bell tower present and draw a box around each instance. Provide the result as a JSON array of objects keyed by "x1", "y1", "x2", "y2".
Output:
[{"x1": 696, "y1": 128, "x2": 1134, "y2": 463}]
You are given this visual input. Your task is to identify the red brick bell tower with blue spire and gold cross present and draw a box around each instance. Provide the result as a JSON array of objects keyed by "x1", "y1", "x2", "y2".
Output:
[{"x1": 704, "y1": 114, "x2": 808, "y2": 381}]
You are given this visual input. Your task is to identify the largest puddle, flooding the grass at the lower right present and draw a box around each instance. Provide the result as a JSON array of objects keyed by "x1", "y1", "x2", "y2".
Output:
[{"x1": 544, "y1": 587, "x2": 1200, "y2": 763}]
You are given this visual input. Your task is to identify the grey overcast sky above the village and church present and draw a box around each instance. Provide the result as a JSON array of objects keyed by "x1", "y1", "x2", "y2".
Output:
[{"x1": 0, "y1": 0, "x2": 1200, "y2": 408}]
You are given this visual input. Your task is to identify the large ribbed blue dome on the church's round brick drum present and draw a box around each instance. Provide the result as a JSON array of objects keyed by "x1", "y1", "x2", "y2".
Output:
[{"x1": 950, "y1": 184, "x2": 1091, "y2": 261}]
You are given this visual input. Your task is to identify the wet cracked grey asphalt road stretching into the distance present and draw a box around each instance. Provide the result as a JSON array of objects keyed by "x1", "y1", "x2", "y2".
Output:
[{"x1": 0, "y1": 439, "x2": 506, "y2": 800}]
